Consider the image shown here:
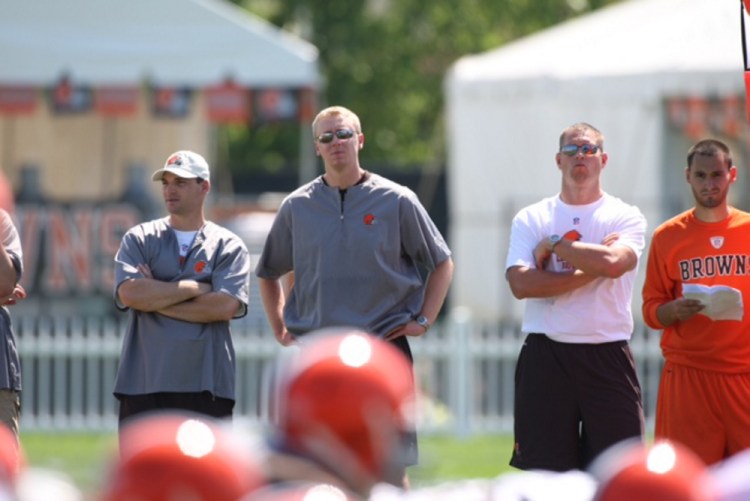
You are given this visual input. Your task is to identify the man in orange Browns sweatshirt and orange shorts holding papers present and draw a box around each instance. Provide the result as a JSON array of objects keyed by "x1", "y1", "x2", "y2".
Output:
[{"x1": 643, "y1": 139, "x2": 750, "y2": 464}]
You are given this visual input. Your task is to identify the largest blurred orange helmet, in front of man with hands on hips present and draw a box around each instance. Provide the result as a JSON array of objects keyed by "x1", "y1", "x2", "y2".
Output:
[{"x1": 275, "y1": 329, "x2": 414, "y2": 492}]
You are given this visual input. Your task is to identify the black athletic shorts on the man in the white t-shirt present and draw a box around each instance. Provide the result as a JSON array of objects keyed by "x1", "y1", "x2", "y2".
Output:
[{"x1": 510, "y1": 334, "x2": 645, "y2": 471}]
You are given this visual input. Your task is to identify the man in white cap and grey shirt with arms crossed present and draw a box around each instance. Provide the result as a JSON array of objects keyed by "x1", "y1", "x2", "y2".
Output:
[{"x1": 114, "y1": 151, "x2": 250, "y2": 442}]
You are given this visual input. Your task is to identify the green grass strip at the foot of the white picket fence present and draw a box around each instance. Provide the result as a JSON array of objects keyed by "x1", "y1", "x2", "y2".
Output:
[{"x1": 21, "y1": 433, "x2": 512, "y2": 494}]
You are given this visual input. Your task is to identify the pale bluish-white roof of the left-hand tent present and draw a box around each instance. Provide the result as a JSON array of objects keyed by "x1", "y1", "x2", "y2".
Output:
[{"x1": 0, "y1": 0, "x2": 319, "y2": 88}]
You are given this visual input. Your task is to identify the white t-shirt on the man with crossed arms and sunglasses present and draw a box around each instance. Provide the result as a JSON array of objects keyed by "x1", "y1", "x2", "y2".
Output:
[{"x1": 505, "y1": 194, "x2": 646, "y2": 344}]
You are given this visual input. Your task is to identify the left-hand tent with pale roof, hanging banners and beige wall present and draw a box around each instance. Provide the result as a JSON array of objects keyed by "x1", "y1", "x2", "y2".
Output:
[{"x1": 0, "y1": 0, "x2": 320, "y2": 200}]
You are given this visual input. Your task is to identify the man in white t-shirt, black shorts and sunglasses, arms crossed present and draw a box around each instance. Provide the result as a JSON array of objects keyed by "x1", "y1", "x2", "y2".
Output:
[{"x1": 505, "y1": 123, "x2": 646, "y2": 471}]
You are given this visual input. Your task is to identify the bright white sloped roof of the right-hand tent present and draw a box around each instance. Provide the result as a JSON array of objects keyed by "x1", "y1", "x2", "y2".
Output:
[{"x1": 462, "y1": 0, "x2": 742, "y2": 84}]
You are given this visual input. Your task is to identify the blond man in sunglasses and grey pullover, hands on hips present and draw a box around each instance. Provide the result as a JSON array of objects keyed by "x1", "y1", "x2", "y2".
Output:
[{"x1": 255, "y1": 106, "x2": 453, "y2": 484}]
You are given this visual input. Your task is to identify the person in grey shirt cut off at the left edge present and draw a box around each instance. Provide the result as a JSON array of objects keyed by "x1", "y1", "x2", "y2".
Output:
[{"x1": 0, "y1": 172, "x2": 26, "y2": 438}]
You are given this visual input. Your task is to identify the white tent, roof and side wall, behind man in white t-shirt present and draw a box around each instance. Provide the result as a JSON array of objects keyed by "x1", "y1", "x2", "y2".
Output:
[{"x1": 445, "y1": 0, "x2": 744, "y2": 319}]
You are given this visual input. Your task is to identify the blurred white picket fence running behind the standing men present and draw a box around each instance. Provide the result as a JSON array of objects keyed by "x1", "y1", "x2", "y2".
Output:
[{"x1": 14, "y1": 313, "x2": 662, "y2": 435}]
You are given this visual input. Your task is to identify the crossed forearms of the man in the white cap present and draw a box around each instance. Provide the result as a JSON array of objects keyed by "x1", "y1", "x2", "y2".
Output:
[{"x1": 117, "y1": 264, "x2": 241, "y2": 323}]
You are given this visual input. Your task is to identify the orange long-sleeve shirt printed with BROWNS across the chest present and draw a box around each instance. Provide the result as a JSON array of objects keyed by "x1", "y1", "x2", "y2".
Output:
[{"x1": 643, "y1": 209, "x2": 750, "y2": 373}]
